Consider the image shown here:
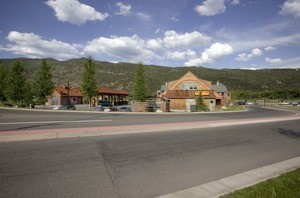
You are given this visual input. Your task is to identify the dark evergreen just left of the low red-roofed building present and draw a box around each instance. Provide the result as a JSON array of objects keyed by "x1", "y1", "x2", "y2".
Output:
[{"x1": 34, "y1": 60, "x2": 54, "y2": 105}]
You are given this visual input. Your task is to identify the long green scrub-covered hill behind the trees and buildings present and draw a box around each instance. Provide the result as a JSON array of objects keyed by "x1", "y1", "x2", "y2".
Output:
[{"x1": 0, "y1": 58, "x2": 300, "y2": 94}]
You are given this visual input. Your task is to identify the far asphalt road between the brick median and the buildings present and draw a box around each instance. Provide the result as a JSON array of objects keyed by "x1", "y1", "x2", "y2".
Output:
[{"x1": 0, "y1": 106, "x2": 295, "y2": 132}]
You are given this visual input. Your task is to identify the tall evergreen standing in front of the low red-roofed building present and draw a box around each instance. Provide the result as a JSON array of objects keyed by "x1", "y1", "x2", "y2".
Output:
[{"x1": 81, "y1": 56, "x2": 98, "y2": 109}]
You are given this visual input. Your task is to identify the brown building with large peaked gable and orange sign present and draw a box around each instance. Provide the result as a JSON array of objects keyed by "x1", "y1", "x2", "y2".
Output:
[{"x1": 158, "y1": 72, "x2": 225, "y2": 111}]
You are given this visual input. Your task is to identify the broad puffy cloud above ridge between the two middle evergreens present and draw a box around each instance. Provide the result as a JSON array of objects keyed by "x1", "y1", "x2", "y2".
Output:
[{"x1": 84, "y1": 35, "x2": 155, "y2": 62}]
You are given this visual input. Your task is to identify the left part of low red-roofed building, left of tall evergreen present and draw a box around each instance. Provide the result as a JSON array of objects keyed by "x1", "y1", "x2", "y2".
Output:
[{"x1": 48, "y1": 86, "x2": 83, "y2": 106}]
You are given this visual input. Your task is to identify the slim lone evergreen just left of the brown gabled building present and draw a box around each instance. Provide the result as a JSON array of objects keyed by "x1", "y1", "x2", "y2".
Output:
[{"x1": 133, "y1": 63, "x2": 147, "y2": 102}]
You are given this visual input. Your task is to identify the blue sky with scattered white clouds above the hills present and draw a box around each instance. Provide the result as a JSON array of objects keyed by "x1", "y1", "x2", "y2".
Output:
[{"x1": 0, "y1": 0, "x2": 300, "y2": 69}]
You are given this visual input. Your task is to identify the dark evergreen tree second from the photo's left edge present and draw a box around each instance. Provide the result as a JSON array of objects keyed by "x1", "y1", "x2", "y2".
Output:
[{"x1": 6, "y1": 61, "x2": 25, "y2": 105}]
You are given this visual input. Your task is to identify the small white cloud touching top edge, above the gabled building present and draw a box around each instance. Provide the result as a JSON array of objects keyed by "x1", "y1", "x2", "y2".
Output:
[{"x1": 195, "y1": 0, "x2": 226, "y2": 16}]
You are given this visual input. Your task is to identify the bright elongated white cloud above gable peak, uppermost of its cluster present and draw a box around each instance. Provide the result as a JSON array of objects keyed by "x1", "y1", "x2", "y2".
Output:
[{"x1": 163, "y1": 30, "x2": 211, "y2": 48}]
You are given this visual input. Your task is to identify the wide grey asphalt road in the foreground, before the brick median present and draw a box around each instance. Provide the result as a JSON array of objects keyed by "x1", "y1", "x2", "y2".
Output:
[{"x1": 0, "y1": 119, "x2": 300, "y2": 198}]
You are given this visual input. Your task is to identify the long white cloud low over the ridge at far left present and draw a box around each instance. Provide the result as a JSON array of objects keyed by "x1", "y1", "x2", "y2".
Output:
[{"x1": 2, "y1": 31, "x2": 81, "y2": 60}]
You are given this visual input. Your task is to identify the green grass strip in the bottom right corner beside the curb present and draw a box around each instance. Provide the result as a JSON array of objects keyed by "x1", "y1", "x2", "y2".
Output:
[{"x1": 222, "y1": 169, "x2": 300, "y2": 198}]
